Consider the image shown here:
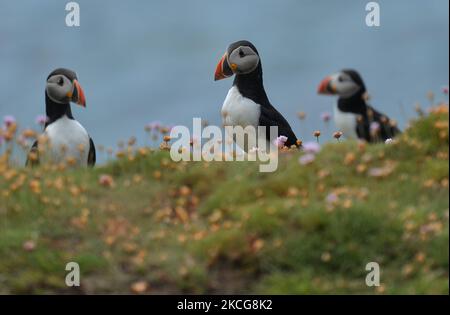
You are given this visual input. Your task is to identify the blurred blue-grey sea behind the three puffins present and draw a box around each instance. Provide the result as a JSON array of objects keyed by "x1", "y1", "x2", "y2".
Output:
[{"x1": 0, "y1": 0, "x2": 449, "y2": 162}]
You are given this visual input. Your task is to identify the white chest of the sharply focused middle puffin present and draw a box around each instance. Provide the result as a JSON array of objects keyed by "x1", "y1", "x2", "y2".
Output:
[{"x1": 221, "y1": 86, "x2": 261, "y2": 127}]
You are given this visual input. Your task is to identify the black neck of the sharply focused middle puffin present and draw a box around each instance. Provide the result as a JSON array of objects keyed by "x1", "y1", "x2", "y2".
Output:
[{"x1": 233, "y1": 62, "x2": 269, "y2": 105}]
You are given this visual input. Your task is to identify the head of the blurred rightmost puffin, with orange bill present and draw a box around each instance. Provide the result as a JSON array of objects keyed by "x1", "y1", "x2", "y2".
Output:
[{"x1": 317, "y1": 69, "x2": 366, "y2": 98}]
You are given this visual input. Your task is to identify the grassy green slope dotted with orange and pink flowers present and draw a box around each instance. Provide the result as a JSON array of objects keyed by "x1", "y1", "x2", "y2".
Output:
[{"x1": 0, "y1": 107, "x2": 449, "y2": 294}]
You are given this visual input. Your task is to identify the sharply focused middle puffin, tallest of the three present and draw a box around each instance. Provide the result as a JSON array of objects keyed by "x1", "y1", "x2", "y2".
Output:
[{"x1": 214, "y1": 40, "x2": 299, "y2": 152}]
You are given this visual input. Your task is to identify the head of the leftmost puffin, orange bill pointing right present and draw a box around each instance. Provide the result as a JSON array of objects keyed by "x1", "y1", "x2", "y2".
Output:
[{"x1": 45, "y1": 68, "x2": 86, "y2": 107}]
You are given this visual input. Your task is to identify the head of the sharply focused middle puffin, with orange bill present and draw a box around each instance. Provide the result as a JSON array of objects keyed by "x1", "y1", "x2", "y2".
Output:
[{"x1": 214, "y1": 40, "x2": 260, "y2": 81}]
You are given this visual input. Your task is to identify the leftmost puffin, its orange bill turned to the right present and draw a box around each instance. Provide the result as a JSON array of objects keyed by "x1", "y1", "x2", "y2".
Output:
[{"x1": 26, "y1": 68, "x2": 96, "y2": 167}]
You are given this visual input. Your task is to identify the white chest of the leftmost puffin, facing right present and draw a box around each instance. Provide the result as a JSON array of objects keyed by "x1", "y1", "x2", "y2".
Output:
[{"x1": 44, "y1": 116, "x2": 89, "y2": 166}]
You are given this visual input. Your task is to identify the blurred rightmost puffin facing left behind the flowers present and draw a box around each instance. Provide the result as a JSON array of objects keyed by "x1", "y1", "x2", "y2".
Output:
[{"x1": 317, "y1": 69, "x2": 400, "y2": 142}]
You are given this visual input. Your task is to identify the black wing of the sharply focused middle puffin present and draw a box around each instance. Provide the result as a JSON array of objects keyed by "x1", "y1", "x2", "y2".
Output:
[{"x1": 259, "y1": 106, "x2": 297, "y2": 147}]
